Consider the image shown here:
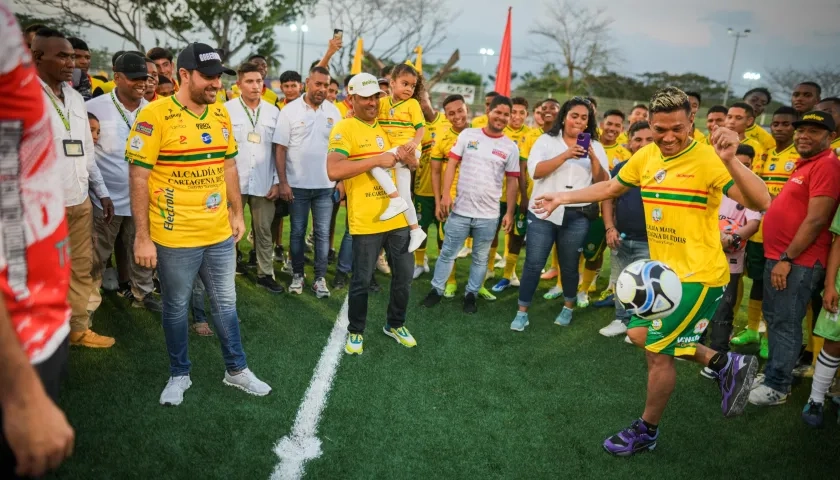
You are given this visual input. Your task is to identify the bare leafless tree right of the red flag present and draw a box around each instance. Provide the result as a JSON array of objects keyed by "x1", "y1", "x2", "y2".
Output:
[{"x1": 530, "y1": 0, "x2": 617, "y2": 95}]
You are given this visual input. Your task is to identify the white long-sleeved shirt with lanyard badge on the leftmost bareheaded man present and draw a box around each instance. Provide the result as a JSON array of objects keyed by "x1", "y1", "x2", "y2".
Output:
[{"x1": 38, "y1": 78, "x2": 109, "y2": 207}]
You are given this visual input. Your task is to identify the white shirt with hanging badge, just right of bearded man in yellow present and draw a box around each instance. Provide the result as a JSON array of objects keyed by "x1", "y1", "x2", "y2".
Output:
[{"x1": 225, "y1": 97, "x2": 280, "y2": 197}]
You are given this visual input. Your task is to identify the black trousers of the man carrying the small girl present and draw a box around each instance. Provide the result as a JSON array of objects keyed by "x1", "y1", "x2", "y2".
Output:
[{"x1": 347, "y1": 227, "x2": 414, "y2": 333}]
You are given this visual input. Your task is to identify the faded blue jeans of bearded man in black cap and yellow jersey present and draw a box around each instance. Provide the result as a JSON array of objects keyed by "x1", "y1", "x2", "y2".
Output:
[{"x1": 156, "y1": 237, "x2": 248, "y2": 377}]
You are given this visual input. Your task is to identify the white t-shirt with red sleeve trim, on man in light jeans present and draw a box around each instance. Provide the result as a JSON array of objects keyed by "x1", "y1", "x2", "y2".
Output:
[{"x1": 449, "y1": 128, "x2": 519, "y2": 219}]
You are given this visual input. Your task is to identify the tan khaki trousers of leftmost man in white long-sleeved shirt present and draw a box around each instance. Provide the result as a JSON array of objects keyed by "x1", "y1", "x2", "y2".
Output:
[{"x1": 65, "y1": 198, "x2": 93, "y2": 332}]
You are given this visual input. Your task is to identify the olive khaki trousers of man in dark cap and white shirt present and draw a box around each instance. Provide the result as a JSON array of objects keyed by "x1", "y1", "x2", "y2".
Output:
[{"x1": 88, "y1": 205, "x2": 155, "y2": 311}]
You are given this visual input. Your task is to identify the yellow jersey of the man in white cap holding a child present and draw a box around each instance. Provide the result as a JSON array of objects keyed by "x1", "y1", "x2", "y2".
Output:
[{"x1": 329, "y1": 117, "x2": 408, "y2": 235}]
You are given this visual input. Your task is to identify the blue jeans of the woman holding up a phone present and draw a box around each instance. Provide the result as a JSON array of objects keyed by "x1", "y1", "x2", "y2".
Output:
[{"x1": 520, "y1": 211, "x2": 589, "y2": 307}]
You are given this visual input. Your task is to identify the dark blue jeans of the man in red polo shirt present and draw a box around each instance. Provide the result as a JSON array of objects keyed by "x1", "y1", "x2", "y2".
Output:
[{"x1": 761, "y1": 259, "x2": 825, "y2": 393}]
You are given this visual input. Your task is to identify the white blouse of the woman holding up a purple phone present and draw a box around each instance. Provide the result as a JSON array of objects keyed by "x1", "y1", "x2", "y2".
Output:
[{"x1": 528, "y1": 133, "x2": 610, "y2": 225}]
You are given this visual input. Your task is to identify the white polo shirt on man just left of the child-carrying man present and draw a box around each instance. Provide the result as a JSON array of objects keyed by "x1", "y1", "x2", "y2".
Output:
[{"x1": 274, "y1": 95, "x2": 341, "y2": 189}]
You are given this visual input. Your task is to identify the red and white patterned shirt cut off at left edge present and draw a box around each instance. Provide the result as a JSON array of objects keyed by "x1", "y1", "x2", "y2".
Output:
[{"x1": 0, "y1": 2, "x2": 70, "y2": 364}]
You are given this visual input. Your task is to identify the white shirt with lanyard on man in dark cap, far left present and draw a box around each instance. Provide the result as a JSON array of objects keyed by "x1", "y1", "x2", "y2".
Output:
[{"x1": 85, "y1": 90, "x2": 149, "y2": 217}]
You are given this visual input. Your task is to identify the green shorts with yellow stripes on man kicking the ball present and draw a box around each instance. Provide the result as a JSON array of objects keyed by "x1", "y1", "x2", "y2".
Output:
[{"x1": 627, "y1": 283, "x2": 723, "y2": 357}]
